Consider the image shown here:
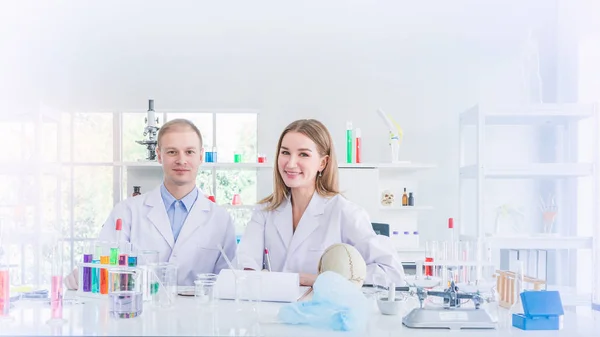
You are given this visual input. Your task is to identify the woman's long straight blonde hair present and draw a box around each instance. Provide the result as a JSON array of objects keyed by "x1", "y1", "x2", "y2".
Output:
[{"x1": 258, "y1": 119, "x2": 340, "y2": 207}]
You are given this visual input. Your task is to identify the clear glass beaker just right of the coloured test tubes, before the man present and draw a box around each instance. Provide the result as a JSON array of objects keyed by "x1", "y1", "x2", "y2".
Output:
[{"x1": 150, "y1": 262, "x2": 177, "y2": 308}]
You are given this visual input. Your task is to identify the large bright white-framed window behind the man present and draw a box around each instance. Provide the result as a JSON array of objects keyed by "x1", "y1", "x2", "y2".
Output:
[{"x1": 0, "y1": 110, "x2": 257, "y2": 286}]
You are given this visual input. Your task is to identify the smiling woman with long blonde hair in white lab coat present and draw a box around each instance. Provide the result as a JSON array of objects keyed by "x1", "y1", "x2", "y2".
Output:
[{"x1": 237, "y1": 119, "x2": 405, "y2": 286}]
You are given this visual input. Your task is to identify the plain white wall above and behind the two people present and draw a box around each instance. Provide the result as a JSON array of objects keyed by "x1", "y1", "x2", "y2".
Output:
[{"x1": 0, "y1": 0, "x2": 550, "y2": 239}]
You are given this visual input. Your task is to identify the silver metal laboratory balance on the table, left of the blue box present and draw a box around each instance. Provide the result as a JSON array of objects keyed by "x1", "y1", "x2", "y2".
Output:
[{"x1": 402, "y1": 281, "x2": 496, "y2": 330}]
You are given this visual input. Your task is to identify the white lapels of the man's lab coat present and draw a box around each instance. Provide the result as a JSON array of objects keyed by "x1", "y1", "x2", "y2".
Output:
[{"x1": 144, "y1": 185, "x2": 212, "y2": 248}]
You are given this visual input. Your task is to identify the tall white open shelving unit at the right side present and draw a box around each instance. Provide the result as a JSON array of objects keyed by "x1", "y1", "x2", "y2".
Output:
[{"x1": 458, "y1": 104, "x2": 600, "y2": 302}]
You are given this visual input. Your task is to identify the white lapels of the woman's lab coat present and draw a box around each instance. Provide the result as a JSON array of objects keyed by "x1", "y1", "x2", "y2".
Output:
[{"x1": 274, "y1": 191, "x2": 329, "y2": 256}]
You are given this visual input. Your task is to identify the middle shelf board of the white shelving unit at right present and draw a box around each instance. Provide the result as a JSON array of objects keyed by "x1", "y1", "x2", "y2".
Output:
[{"x1": 460, "y1": 163, "x2": 594, "y2": 179}]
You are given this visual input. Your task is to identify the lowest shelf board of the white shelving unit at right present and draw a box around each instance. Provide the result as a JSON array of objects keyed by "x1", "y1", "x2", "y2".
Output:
[{"x1": 460, "y1": 235, "x2": 593, "y2": 250}]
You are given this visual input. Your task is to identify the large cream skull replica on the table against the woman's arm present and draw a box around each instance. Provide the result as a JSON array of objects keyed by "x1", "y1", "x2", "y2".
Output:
[{"x1": 318, "y1": 243, "x2": 367, "y2": 288}]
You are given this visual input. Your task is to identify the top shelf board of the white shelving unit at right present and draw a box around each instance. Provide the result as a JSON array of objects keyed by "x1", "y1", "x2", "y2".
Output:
[{"x1": 460, "y1": 104, "x2": 596, "y2": 125}]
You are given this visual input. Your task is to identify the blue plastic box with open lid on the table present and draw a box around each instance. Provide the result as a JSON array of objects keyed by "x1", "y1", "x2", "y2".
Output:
[{"x1": 512, "y1": 291, "x2": 565, "y2": 330}]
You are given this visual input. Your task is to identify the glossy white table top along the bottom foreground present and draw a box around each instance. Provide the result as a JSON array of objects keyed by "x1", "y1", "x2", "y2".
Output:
[{"x1": 0, "y1": 290, "x2": 600, "y2": 337}]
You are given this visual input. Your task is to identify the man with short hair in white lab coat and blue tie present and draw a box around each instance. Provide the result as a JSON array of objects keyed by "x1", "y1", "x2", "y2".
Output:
[{"x1": 65, "y1": 119, "x2": 236, "y2": 289}]
